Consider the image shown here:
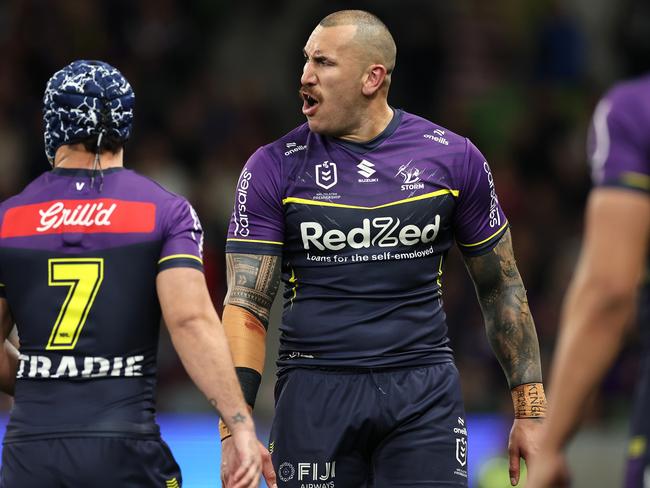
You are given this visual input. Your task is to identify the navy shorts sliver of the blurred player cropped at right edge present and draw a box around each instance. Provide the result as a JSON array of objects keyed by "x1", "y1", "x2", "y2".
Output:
[{"x1": 624, "y1": 356, "x2": 650, "y2": 488}]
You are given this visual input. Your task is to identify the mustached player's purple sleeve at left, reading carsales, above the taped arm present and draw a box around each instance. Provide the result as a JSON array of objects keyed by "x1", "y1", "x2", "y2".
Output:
[{"x1": 226, "y1": 147, "x2": 284, "y2": 256}]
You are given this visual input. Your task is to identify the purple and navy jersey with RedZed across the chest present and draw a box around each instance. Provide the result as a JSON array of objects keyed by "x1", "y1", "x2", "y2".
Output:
[{"x1": 226, "y1": 110, "x2": 507, "y2": 367}]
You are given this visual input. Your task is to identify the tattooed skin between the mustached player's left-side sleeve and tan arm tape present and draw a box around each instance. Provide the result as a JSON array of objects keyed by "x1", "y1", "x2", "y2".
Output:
[{"x1": 225, "y1": 253, "x2": 280, "y2": 327}]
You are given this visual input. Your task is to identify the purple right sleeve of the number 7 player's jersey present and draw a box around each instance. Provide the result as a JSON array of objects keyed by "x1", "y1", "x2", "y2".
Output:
[{"x1": 158, "y1": 197, "x2": 203, "y2": 271}]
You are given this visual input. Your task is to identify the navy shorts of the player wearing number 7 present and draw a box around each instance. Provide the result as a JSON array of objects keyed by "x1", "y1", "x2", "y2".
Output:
[{"x1": 0, "y1": 437, "x2": 182, "y2": 488}]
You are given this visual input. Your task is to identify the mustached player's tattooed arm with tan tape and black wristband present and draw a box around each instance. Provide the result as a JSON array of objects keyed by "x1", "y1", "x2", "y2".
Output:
[{"x1": 219, "y1": 253, "x2": 280, "y2": 486}]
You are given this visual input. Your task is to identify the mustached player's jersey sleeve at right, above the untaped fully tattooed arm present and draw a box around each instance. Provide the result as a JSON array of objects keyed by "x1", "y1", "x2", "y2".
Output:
[{"x1": 454, "y1": 141, "x2": 508, "y2": 256}]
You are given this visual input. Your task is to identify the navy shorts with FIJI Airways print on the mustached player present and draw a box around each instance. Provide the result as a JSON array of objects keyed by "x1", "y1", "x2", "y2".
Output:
[{"x1": 269, "y1": 363, "x2": 467, "y2": 488}]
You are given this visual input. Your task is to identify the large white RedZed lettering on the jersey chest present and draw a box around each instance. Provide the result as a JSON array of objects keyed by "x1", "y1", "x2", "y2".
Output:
[{"x1": 300, "y1": 215, "x2": 440, "y2": 251}]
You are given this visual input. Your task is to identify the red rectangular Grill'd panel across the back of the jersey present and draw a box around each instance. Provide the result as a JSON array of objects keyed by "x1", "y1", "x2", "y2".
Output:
[{"x1": 0, "y1": 198, "x2": 156, "y2": 238}]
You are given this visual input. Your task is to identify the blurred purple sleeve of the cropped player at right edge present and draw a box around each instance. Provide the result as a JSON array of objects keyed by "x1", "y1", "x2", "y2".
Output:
[{"x1": 587, "y1": 90, "x2": 650, "y2": 193}]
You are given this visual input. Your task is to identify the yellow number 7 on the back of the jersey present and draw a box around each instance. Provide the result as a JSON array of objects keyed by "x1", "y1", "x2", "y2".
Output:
[{"x1": 46, "y1": 258, "x2": 104, "y2": 350}]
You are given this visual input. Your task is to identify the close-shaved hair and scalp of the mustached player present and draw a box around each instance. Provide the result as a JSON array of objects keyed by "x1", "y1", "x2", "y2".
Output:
[{"x1": 318, "y1": 10, "x2": 397, "y2": 74}]
